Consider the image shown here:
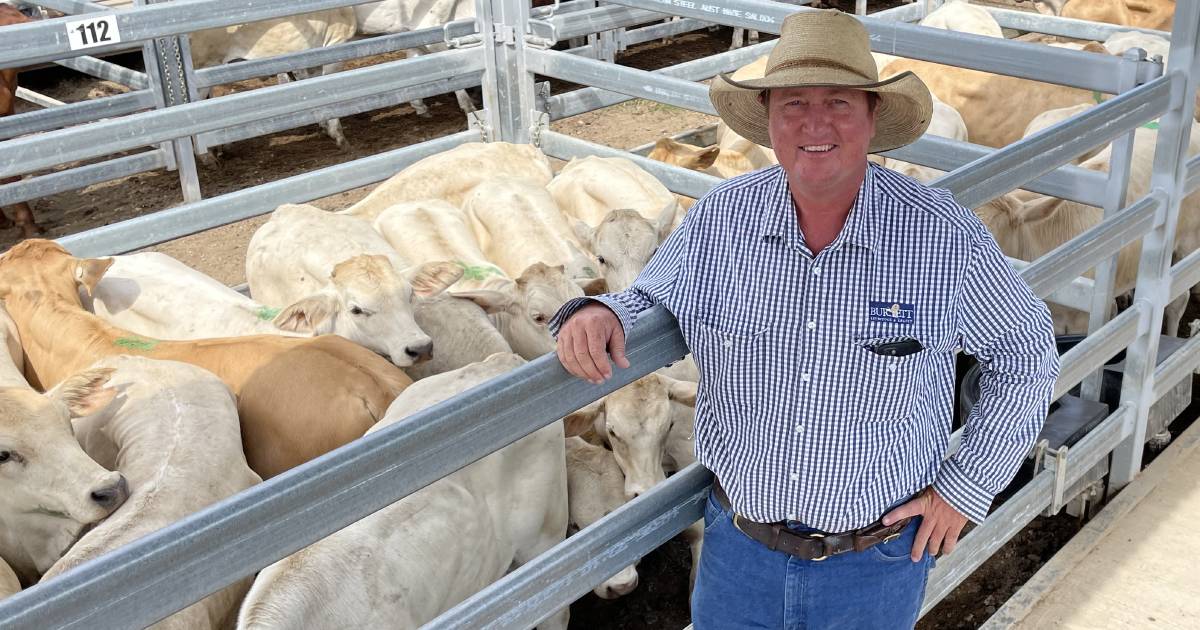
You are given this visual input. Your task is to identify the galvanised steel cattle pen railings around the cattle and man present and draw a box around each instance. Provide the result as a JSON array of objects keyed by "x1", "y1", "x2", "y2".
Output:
[{"x1": 0, "y1": 0, "x2": 1200, "y2": 629}]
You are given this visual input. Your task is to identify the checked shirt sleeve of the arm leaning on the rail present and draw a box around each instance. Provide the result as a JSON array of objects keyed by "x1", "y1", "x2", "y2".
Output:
[{"x1": 550, "y1": 202, "x2": 703, "y2": 337}]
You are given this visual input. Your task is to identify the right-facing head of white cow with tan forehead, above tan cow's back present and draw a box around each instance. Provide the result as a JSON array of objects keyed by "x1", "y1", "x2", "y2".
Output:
[{"x1": 275, "y1": 254, "x2": 462, "y2": 367}]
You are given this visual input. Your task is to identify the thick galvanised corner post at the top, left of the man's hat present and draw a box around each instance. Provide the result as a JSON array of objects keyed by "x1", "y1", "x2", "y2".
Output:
[{"x1": 476, "y1": 0, "x2": 536, "y2": 143}]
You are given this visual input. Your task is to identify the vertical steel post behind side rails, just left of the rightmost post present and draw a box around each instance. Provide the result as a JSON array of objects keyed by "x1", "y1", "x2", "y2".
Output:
[{"x1": 1081, "y1": 49, "x2": 1146, "y2": 401}]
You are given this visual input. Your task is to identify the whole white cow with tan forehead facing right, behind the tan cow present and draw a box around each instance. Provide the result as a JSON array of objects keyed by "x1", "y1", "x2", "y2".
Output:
[{"x1": 246, "y1": 204, "x2": 462, "y2": 367}]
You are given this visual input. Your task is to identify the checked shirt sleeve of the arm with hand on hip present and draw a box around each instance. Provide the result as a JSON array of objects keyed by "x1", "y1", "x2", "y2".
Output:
[{"x1": 934, "y1": 232, "x2": 1058, "y2": 523}]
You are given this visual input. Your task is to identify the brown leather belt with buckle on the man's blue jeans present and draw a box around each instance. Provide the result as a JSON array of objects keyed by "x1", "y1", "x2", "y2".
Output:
[{"x1": 713, "y1": 481, "x2": 911, "y2": 562}]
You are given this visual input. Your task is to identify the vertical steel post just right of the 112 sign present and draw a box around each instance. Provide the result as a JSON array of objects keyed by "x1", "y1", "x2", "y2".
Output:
[{"x1": 133, "y1": 0, "x2": 203, "y2": 203}]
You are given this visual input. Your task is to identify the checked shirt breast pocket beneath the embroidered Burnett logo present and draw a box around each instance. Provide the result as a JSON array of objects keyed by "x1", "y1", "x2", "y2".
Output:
[{"x1": 853, "y1": 340, "x2": 929, "y2": 421}]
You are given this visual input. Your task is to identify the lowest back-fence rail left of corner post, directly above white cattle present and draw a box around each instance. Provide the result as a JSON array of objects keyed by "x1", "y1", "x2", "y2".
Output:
[{"x1": 58, "y1": 131, "x2": 479, "y2": 257}]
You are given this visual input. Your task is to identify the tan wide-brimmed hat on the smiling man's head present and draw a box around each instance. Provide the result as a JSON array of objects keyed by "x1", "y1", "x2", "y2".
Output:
[{"x1": 708, "y1": 10, "x2": 934, "y2": 154}]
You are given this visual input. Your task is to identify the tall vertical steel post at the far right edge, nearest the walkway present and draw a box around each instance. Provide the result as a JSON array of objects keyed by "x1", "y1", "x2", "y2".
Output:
[{"x1": 1109, "y1": 2, "x2": 1200, "y2": 492}]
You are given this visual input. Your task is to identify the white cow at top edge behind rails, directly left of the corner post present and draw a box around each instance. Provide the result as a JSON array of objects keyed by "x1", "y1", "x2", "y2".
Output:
[{"x1": 354, "y1": 0, "x2": 475, "y2": 118}]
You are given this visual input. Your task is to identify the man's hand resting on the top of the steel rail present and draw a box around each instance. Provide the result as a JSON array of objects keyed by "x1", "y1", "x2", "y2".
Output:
[{"x1": 558, "y1": 302, "x2": 629, "y2": 385}]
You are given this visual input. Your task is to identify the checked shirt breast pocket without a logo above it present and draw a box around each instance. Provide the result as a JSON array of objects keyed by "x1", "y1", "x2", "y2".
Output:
[{"x1": 689, "y1": 322, "x2": 768, "y2": 412}]
